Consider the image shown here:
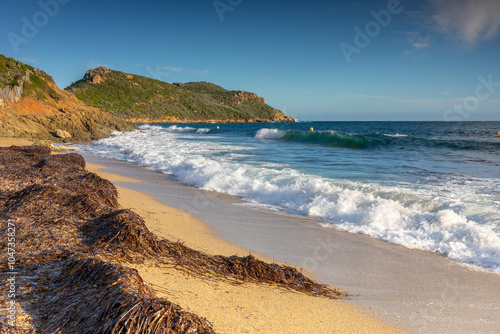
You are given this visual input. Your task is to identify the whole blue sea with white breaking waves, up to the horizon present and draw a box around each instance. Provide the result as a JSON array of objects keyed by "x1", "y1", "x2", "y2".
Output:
[{"x1": 81, "y1": 122, "x2": 500, "y2": 274}]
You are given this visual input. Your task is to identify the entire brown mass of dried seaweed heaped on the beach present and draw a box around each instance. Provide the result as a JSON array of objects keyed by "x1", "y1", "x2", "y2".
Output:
[{"x1": 0, "y1": 146, "x2": 342, "y2": 333}]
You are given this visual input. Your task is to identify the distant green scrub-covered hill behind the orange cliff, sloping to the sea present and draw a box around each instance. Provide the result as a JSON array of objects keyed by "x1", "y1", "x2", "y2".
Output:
[{"x1": 66, "y1": 67, "x2": 294, "y2": 122}]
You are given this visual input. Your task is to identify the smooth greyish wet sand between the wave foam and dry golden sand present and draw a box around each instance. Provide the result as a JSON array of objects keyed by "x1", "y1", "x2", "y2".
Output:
[{"x1": 86, "y1": 157, "x2": 500, "y2": 333}]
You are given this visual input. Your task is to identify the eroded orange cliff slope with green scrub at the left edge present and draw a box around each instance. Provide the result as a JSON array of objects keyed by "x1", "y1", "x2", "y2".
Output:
[{"x1": 0, "y1": 55, "x2": 135, "y2": 141}]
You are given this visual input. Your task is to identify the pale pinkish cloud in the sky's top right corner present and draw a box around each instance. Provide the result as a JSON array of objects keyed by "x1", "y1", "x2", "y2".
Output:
[{"x1": 428, "y1": 0, "x2": 500, "y2": 46}]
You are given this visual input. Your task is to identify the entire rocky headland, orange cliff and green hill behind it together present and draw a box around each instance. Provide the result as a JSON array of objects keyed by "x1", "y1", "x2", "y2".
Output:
[{"x1": 0, "y1": 55, "x2": 294, "y2": 142}]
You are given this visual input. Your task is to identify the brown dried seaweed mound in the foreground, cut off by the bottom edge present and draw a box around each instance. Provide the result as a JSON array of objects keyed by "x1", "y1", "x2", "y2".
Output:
[{"x1": 39, "y1": 257, "x2": 215, "y2": 334}]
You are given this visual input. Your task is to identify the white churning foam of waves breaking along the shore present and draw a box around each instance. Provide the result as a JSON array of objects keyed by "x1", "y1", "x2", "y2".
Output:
[{"x1": 82, "y1": 126, "x2": 500, "y2": 273}]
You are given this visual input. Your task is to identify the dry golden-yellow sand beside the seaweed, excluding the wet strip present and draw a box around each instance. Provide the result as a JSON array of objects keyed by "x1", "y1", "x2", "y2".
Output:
[{"x1": 0, "y1": 140, "x2": 405, "y2": 333}]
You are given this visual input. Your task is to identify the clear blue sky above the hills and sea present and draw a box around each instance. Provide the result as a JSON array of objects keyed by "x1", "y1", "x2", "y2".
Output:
[{"x1": 0, "y1": 0, "x2": 500, "y2": 121}]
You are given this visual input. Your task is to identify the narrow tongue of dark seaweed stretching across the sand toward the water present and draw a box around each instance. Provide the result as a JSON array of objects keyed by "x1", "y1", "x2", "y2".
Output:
[{"x1": 86, "y1": 210, "x2": 343, "y2": 298}]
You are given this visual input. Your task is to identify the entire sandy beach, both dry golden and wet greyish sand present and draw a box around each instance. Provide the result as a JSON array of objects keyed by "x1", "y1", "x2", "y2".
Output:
[{"x1": 0, "y1": 139, "x2": 500, "y2": 333}]
